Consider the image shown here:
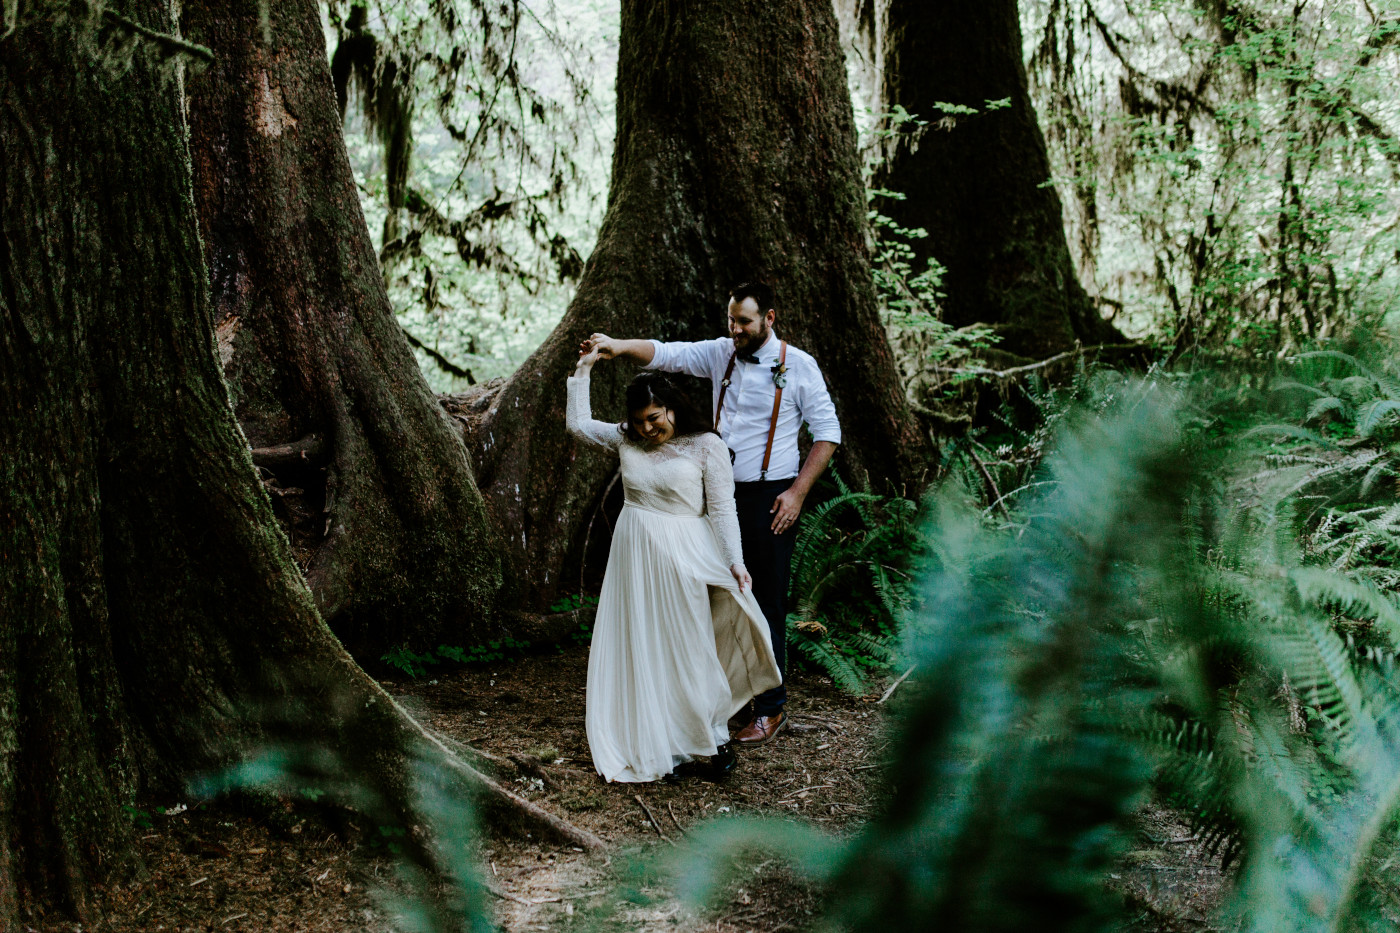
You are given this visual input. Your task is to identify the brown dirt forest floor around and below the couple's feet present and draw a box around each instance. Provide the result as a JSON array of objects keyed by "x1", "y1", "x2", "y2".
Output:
[{"x1": 28, "y1": 647, "x2": 1225, "y2": 933}]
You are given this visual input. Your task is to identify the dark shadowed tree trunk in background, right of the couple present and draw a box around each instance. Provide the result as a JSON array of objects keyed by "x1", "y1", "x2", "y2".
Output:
[{"x1": 868, "y1": 0, "x2": 1123, "y2": 356}]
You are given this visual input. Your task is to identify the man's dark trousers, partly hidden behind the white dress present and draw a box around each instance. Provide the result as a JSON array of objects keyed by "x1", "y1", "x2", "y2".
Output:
[{"x1": 734, "y1": 479, "x2": 797, "y2": 716}]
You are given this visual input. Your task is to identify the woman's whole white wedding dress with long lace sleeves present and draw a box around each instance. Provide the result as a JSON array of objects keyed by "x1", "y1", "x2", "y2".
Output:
[{"x1": 568, "y1": 375, "x2": 783, "y2": 782}]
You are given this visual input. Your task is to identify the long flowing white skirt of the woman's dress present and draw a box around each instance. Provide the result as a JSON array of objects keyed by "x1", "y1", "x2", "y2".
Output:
[{"x1": 587, "y1": 503, "x2": 783, "y2": 782}]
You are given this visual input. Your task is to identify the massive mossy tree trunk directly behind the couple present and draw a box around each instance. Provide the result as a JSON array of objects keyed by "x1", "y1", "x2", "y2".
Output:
[{"x1": 473, "y1": 0, "x2": 928, "y2": 601}]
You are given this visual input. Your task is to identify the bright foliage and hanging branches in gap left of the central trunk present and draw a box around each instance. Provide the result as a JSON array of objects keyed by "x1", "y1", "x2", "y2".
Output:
[{"x1": 329, "y1": 0, "x2": 617, "y2": 388}]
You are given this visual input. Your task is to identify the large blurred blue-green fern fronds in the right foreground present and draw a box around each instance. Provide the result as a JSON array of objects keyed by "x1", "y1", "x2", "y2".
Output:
[{"x1": 674, "y1": 361, "x2": 1400, "y2": 933}]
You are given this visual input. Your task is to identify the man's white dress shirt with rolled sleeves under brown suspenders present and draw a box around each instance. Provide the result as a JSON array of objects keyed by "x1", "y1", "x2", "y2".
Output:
[{"x1": 647, "y1": 331, "x2": 841, "y2": 483}]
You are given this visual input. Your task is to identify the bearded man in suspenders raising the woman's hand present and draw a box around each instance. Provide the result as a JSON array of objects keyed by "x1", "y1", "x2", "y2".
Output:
[{"x1": 584, "y1": 282, "x2": 841, "y2": 747}]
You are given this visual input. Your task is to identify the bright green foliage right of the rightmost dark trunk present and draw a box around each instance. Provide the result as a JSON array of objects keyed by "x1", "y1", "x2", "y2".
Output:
[{"x1": 1022, "y1": 0, "x2": 1400, "y2": 353}]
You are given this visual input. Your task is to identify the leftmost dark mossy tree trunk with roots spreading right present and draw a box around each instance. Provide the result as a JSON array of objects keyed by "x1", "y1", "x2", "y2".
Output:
[{"x1": 0, "y1": 0, "x2": 587, "y2": 929}]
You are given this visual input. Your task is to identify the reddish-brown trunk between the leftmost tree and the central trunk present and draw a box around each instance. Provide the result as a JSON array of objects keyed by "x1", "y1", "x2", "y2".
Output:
[{"x1": 182, "y1": 0, "x2": 500, "y2": 657}]
